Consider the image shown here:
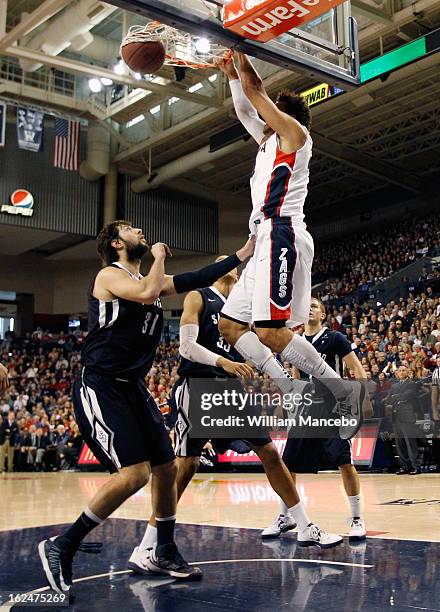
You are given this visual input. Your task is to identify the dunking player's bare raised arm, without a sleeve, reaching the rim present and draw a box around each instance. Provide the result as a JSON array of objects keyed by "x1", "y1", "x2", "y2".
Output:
[{"x1": 234, "y1": 51, "x2": 307, "y2": 153}]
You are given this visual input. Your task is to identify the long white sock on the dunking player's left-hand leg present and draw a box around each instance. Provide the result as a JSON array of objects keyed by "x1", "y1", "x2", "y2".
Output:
[{"x1": 234, "y1": 331, "x2": 302, "y2": 394}]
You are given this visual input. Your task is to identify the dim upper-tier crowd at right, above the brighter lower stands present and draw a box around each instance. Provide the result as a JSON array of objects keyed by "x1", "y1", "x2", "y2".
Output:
[{"x1": 312, "y1": 214, "x2": 440, "y2": 299}]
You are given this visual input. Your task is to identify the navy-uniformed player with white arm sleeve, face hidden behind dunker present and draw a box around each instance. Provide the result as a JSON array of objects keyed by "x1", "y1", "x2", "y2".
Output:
[{"x1": 128, "y1": 260, "x2": 342, "y2": 573}]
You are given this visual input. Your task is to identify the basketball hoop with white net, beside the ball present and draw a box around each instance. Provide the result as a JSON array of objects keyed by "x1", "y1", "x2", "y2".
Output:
[{"x1": 121, "y1": 21, "x2": 230, "y2": 70}]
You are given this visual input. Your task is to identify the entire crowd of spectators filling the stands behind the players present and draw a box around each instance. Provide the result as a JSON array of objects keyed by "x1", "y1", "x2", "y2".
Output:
[{"x1": 0, "y1": 216, "x2": 440, "y2": 472}]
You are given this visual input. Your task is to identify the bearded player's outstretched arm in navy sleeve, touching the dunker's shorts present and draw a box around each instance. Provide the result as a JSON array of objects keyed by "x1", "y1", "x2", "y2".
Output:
[{"x1": 160, "y1": 237, "x2": 255, "y2": 295}]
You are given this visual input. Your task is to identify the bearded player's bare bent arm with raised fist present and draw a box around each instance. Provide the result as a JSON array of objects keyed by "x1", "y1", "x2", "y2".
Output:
[{"x1": 93, "y1": 242, "x2": 171, "y2": 304}]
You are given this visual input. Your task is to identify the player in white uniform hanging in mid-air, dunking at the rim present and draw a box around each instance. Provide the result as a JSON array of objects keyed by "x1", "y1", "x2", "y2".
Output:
[{"x1": 216, "y1": 52, "x2": 364, "y2": 438}]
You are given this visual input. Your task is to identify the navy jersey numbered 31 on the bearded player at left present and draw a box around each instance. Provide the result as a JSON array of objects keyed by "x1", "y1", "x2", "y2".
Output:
[{"x1": 81, "y1": 263, "x2": 163, "y2": 379}]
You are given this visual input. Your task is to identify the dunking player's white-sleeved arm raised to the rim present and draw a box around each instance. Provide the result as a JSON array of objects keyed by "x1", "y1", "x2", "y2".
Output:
[{"x1": 214, "y1": 57, "x2": 265, "y2": 144}]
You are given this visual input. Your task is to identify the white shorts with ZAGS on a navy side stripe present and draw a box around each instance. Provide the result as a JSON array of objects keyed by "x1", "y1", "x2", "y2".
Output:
[{"x1": 222, "y1": 217, "x2": 314, "y2": 327}]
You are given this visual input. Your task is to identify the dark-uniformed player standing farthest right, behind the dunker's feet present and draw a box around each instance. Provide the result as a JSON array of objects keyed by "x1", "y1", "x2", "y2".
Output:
[{"x1": 261, "y1": 298, "x2": 371, "y2": 541}]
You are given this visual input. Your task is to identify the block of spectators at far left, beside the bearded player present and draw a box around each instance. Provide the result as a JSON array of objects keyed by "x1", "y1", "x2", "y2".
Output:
[{"x1": 0, "y1": 330, "x2": 85, "y2": 471}]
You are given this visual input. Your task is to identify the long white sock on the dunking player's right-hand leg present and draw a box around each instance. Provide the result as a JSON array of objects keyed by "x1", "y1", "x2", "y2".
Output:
[{"x1": 281, "y1": 334, "x2": 351, "y2": 400}]
